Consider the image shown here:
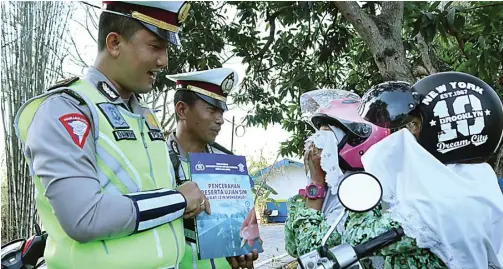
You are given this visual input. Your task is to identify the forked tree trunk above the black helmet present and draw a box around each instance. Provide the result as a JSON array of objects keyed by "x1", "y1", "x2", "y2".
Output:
[{"x1": 334, "y1": 1, "x2": 415, "y2": 83}]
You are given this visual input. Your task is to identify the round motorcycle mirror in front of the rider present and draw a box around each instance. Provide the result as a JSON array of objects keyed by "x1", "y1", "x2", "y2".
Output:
[{"x1": 337, "y1": 172, "x2": 382, "y2": 212}]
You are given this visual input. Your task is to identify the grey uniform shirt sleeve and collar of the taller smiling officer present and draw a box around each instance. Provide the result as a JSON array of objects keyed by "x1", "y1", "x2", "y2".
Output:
[{"x1": 25, "y1": 67, "x2": 162, "y2": 242}]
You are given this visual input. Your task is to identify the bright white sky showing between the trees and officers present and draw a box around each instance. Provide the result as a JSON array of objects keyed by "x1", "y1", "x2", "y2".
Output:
[{"x1": 0, "y1": 1, "x2": 298, "y2": 171}]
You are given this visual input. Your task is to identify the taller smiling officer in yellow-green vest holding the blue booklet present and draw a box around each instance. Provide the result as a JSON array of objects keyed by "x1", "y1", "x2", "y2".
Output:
[{"x1": 15, "y1": 2, "x2": 210, "y2": 268}]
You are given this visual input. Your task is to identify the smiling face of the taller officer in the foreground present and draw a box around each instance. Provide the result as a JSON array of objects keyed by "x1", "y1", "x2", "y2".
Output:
[{"x1": 118, "y1": 29, "x2": 168, "y2": 93}]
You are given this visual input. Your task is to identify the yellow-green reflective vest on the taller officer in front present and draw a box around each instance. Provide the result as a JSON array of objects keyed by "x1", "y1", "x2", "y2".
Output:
[{"x1": 16, "y1": 80, "x2": 185, "y2": 269}]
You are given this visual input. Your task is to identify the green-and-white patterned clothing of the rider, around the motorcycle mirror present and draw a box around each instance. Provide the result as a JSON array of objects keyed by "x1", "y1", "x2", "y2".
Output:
[{"x1": 285, "y1": 195, "x2": 447, "y2": 269}]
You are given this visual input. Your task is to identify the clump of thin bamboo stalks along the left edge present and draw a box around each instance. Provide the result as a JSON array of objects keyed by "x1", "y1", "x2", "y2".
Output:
[{"x1": 0, "y1": 2, "x2": 71, "y2": 243}]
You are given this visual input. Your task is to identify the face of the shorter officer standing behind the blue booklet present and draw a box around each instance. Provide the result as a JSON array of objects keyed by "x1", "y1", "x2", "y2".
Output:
[{"x1": 186, "y1": 99, "x2": 224, "y2": 143}]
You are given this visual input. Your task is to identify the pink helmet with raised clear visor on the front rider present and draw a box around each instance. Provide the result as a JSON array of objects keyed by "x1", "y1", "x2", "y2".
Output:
[{"x1": 311, "y1": 97, "x2": 390, "y2": 170}]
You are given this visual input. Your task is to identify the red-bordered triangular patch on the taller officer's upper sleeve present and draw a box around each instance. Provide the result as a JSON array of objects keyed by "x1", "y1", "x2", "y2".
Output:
[{"x1": 59, "y1": 113, "x2": 91, "y2": 148}]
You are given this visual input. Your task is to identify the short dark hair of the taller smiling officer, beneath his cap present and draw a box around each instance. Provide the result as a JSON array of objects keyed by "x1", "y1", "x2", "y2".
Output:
[{"x1": 98, "y1": 8, "x2": 144, "y2": 51}]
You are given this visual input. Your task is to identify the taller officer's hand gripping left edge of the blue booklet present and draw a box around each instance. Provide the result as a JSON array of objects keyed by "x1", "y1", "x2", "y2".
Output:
[{"x1": 177, "y1": 182, "x2": 211, "y2": 219}]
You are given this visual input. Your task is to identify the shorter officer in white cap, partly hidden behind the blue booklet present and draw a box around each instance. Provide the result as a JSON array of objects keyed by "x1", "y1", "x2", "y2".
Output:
[{"x1": 167, "y1": 68, "x2": 258, "y2": 269}]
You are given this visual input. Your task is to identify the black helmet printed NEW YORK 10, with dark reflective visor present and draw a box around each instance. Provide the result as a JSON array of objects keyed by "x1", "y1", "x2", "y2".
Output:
[{"x1": 358, "y1": 72, "x2": 503, "y2": 164}]
